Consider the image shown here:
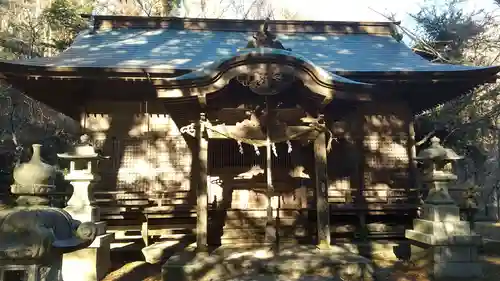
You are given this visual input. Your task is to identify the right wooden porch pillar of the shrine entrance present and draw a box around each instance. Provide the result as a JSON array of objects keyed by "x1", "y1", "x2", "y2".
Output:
[{"x1": 314, "y1": 120, "x2": 330, "y2": 248}]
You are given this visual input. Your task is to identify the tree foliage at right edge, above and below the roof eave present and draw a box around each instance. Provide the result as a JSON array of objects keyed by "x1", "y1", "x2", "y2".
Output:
[{"x1": 412, "y1": 0, "x2": 500, "y2": 203}]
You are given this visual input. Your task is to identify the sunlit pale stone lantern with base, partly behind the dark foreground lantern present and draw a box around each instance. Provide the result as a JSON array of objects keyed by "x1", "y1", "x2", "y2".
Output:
[{"x1": 58, "y1": 135, "x2": 114, "y2": 281}]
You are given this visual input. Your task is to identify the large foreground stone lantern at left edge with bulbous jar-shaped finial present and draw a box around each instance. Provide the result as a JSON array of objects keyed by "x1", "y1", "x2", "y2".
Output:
[{"x1": 0, "y1": 144, "x2": 98, "y2": 281}]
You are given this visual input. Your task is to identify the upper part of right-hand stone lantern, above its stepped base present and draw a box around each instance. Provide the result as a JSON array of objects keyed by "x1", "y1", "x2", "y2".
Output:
[{"x1": 415, "y1": 137, "x2": 463, "y2": 205}]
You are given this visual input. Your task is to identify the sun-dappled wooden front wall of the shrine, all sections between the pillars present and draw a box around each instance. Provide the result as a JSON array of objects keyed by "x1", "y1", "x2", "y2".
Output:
[{"x1": 81, "y1": 102, "x2": 418, "y2": 243}]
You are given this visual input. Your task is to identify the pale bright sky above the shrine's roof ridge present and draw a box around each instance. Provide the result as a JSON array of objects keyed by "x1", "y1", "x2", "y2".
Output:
[{"x1": 96, "y1": 0, "x2": 500, "y2": 38}]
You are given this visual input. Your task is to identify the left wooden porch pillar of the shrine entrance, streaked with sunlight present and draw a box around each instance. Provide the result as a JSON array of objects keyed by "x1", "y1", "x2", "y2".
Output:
[{"x1": 193, "y1": 113, "x2": 208, "y2": 252}]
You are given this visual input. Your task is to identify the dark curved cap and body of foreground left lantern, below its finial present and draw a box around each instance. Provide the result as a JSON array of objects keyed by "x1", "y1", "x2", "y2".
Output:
[{"x1": 0, "y1": 205, "x2": 97, "y2": 281}]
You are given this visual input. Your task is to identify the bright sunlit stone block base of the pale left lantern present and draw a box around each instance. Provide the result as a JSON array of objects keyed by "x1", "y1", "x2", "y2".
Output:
[{"x1": 62, "y1": 234, "x2": 114, "y2": 281}]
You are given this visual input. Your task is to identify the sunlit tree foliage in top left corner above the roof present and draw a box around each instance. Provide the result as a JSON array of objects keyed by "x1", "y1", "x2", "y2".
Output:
[{"x1": 0, "y1": 0, "x2": 91, "y2": 59}]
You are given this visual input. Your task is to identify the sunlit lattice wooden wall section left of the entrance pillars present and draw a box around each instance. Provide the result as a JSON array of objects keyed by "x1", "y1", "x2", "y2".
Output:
[{"x1": 81, "y1": 102, "x2": 196, "y2": 221}]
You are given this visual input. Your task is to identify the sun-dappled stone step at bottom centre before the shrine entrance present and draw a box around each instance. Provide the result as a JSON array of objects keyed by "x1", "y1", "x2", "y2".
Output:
[{"x1": 162, "y1": 245, "x2": 374, "y2": 281}]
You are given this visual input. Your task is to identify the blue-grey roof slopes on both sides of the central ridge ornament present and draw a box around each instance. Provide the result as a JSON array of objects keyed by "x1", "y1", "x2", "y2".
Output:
[{"x1": 0, "y1": 17, "x2": 496, "y2": 72}]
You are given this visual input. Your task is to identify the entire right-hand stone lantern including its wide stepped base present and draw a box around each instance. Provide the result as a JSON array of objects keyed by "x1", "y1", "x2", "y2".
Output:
[{"x1": 405, "y1": 138, "x2": 482, "y2": 278}]
